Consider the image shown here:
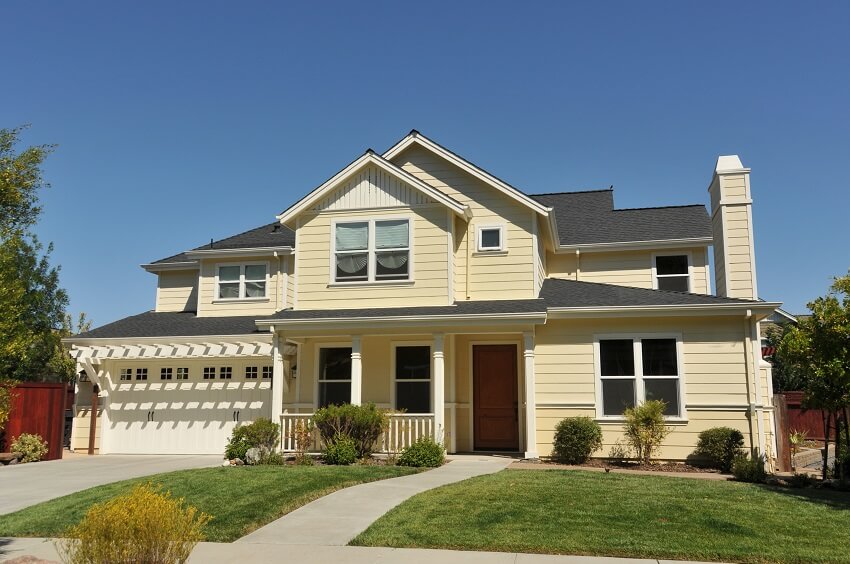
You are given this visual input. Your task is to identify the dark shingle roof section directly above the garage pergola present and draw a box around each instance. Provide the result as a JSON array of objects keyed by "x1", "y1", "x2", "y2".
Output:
[{"x1": 74, "y1": 311, "x2": 260, "y2": 339}]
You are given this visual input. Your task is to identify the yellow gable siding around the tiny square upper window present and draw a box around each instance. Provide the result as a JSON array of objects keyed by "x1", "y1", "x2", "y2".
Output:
[{"x1": 393, "y1": 147, "x2": 536, "y2": 300}]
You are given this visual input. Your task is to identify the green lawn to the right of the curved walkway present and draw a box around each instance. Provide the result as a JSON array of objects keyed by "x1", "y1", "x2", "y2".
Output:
[{"x1": 351, "y1": 470, "x2": 850, "y2": 562}]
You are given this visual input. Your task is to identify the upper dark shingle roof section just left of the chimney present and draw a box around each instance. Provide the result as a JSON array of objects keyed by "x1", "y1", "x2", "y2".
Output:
[{"x1": 531, "y1": 189, "x2": 711, "y2": 245}]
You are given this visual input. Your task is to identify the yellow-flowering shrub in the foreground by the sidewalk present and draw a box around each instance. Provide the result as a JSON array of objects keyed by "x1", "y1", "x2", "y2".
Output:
[{"x1": 56, "y1": 484, "x2": 211, "y2": 564}]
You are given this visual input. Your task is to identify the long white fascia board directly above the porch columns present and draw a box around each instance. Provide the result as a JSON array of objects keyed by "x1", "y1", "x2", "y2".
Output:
[{"x1": 257, "y1": 312, "x2": 546, "y2": 330}]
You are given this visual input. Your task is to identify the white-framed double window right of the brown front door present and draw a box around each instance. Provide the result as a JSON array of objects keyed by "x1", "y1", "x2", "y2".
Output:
[{"x1": 594, "y1": 334, "x2": 685, "y2": 419}]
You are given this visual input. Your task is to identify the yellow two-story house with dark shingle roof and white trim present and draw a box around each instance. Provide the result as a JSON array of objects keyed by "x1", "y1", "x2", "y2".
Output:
[{"x1": 68, "y1": 131, "x2": 779, "y2": 460}]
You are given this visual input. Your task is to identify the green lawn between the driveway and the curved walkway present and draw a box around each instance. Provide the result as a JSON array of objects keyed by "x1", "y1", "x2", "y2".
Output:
[{"x1": 0, "y1": 466, "x2": 415, "y2": 542}]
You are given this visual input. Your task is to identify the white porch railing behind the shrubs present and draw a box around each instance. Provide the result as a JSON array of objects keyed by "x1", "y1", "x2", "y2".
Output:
[{"x1": 280, "y1": 413, "x2": 439, "y2": 453}]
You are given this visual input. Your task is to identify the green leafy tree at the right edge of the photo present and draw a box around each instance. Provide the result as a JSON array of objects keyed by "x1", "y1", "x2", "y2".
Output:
[{"x1": 779, "y1": 271, "x2": 850, "y2": 480}]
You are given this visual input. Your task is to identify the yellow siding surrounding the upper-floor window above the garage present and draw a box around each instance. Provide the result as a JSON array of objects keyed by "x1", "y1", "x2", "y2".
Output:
[{"x1": 198, "y1": 255, "x2": 282, "y2": 317}]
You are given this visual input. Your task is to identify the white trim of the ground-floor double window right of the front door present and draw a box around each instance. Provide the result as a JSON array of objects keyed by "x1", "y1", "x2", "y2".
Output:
[{"x1": 593, "y1": 332, "x2": 688, "y2": 423}]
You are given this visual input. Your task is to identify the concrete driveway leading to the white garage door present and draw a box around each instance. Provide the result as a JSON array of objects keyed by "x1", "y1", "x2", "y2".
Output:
[{"x1": 0, "y1": 452, "x2": 222, "y2": 515}]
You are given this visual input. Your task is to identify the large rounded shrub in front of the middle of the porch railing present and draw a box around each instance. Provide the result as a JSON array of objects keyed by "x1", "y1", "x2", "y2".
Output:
[{"x1": 313, "y1": 403, "x2": 389, "y2": 458}]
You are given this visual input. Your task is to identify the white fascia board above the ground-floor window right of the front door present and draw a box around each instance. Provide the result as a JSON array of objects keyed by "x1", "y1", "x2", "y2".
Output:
[{"x1": 548, "y1": 302, "x2": 781, "y2": 319}]
